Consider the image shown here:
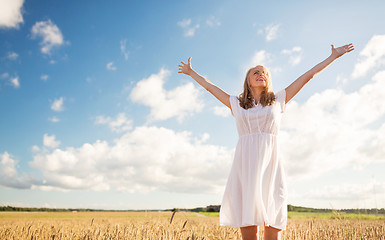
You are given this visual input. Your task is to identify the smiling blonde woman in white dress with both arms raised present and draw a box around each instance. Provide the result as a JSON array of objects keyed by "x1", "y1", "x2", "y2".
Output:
[{"x1": 179, "y1": 44, "x2": 354, "y2": 239}]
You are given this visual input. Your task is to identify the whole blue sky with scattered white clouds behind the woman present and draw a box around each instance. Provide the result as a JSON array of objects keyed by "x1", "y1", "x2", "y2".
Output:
[{"x1": 0, "y1": 0, "x2": 385, "y2": 209}]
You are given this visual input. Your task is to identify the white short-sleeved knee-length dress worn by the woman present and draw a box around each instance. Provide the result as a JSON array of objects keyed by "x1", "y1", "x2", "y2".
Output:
[{"x1": 219, "y1": 89, "x2": 287, "y2": 230}]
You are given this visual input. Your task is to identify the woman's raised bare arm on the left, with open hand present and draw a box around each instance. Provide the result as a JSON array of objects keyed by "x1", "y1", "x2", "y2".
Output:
[{"x1": 178, "y1": 57, "x2": 231, "y2": 109}]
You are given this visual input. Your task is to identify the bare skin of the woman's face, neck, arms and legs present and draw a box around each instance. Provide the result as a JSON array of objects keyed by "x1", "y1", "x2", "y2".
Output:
[{"x1": 178, "y1": 44, "x2": 354, "y2": 240}]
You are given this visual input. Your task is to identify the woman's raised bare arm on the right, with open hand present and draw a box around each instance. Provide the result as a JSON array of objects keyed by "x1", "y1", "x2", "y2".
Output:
[{"x1": 285, "y1": 43, "x2": 354, "y2": 103}]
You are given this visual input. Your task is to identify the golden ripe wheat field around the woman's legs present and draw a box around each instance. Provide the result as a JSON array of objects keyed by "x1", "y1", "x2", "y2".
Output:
[{"x1": 0, "y1": 212, "x2": 385, "y2": 240}]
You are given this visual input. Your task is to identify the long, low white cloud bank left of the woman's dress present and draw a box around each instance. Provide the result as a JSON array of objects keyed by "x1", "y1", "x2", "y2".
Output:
[{"x1": 30, "y1": 127, "x2": 233, "y2": 193}]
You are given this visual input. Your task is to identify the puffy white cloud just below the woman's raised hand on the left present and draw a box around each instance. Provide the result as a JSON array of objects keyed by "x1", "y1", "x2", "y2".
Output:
[{"x1": 130, "y1": 68, "x2": 204, "y2": 121}]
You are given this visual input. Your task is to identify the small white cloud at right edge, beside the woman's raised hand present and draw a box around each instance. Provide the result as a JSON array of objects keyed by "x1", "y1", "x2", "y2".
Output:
[{"x1": 352, "y1": 35, "x2": 385, "y2": 78}]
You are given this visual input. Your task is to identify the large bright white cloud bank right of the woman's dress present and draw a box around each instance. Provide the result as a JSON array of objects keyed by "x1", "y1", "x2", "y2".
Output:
[{"x1": 280, "y1": 71, "x2": 385, "y2": 179}]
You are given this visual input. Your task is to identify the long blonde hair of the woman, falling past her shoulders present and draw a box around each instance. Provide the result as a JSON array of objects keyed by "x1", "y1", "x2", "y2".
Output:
[{"x1": 238, "y1": 65, "x2": 275, "y2": 109}]
